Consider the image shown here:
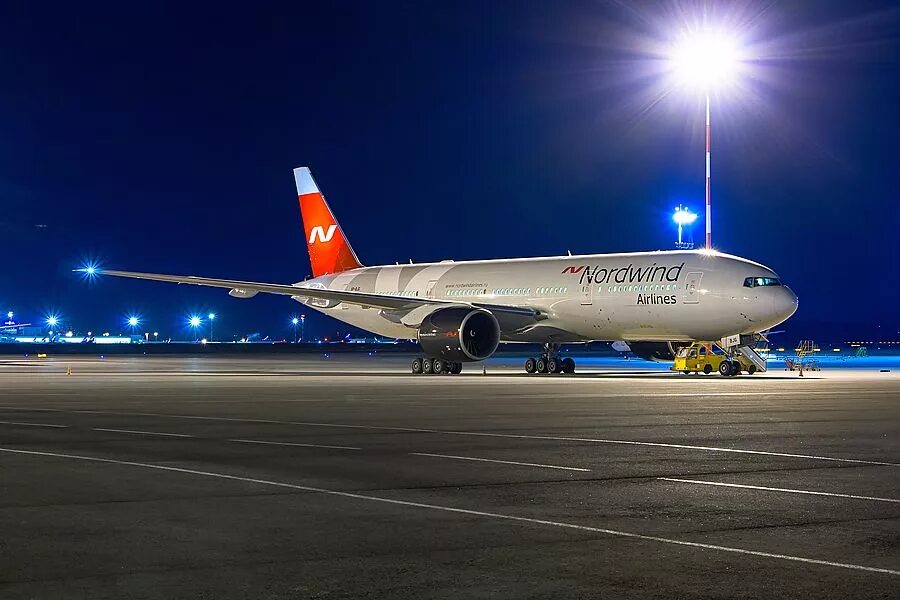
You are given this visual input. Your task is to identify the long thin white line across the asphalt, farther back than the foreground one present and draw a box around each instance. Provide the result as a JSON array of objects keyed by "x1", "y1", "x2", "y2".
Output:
[{"x1": 0, "y1": 406, "x2": 900, "y2": 467}]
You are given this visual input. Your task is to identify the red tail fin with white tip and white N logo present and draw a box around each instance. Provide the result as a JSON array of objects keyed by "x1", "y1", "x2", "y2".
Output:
[{"x1": 294, "y1": 167, "x2": 362, "y2": 277}]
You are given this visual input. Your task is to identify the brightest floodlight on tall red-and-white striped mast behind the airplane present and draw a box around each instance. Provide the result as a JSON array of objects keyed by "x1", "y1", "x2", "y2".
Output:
[{"x1": 668, "y1": 29, "x2": 744, "y2": 250}]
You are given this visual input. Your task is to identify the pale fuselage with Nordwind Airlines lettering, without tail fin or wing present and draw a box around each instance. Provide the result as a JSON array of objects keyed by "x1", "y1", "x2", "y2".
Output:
[{"x1": 295, "y1": 250, "x2": 797, "y2": 343}]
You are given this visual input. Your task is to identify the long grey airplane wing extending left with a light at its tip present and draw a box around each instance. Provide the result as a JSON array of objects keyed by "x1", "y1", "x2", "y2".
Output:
[{"x1": 96, "y1": 269, "x2": 543, "y2": 329}]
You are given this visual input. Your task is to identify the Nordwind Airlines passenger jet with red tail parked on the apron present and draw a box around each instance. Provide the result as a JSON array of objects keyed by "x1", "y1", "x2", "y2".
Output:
[{"x1": 89, "y1": 167, "x2": 797, "y2": 376}]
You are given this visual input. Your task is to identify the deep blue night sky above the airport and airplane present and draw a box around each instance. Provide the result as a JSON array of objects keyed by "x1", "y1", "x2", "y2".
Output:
[{"x1": 0, "y1": 0, "x2": 900, "y2": 339}]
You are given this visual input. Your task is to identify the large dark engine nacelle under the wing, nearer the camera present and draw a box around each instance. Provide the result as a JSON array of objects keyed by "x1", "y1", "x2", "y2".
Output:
[{"x1": 419, "y1": 306, "x2": 500, "y2": 362}]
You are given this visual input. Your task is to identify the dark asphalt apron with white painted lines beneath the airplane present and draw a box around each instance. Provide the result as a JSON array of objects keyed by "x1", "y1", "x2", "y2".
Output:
[{"x1": 0, "y1": 355, "x2": 900, "y2": 600}]
